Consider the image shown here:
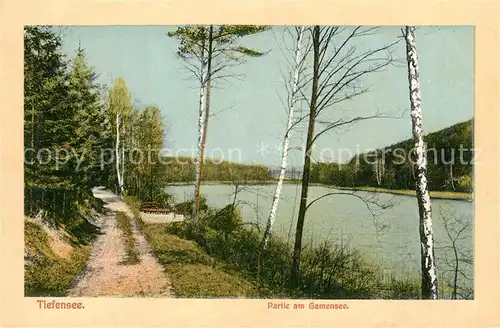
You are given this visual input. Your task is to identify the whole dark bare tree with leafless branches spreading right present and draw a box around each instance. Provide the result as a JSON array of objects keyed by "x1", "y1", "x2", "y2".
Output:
[{"x1": 291, "y1": 25, "x2": 398, "y2": 287}]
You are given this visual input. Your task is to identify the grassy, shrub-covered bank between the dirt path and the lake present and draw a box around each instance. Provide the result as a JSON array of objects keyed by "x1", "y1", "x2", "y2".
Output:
[{"x1": 128, "y1": 199, "x2": 419, "y2": 299}]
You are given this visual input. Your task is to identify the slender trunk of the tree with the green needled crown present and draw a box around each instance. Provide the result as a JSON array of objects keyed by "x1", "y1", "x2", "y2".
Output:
[{"x1": 193, "y1": 29, "x2": 208, "y2": 217}]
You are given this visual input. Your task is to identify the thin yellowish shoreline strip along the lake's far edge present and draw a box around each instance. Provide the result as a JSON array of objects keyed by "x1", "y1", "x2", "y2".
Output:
[{"x1": 166, "y1": 180, "x2": 474, "y2": 202}]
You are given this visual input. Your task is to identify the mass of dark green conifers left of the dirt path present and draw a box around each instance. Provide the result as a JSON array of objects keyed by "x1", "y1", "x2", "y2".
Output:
[{"x1": 24, "y1": 26, "x2": 109, "y2": 241}]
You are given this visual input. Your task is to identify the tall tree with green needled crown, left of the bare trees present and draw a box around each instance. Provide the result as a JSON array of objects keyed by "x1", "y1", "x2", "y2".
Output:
[{"x1": 168, "y1": 25, "x2": 268, "y2": 216}]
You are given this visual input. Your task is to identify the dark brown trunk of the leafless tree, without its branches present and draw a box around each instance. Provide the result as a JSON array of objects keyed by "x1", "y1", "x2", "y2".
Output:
[{"x1": 291, "y1": 25, "x2": 320, "y2": 288}]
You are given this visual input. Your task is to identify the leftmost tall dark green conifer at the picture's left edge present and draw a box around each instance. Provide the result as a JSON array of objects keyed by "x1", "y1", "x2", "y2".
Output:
[{"x1": 24, "y1": 26, "x2": 75, "y2": 218}]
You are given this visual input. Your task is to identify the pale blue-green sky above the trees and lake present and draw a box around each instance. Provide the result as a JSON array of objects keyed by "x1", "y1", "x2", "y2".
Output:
[{"x1": 57, "y1": 26, "x2": 474, "y2": 165}]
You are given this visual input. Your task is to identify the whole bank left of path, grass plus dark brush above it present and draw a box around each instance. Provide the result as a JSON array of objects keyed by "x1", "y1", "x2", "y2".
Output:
[{"x1": 24, "y1": 193, "x2": 104, "y2": 296}]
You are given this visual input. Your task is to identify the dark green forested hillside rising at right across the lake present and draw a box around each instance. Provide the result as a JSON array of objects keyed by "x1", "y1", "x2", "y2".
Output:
[{"x1": 311, "y1": 120, "x2": 474, "y2": 192}]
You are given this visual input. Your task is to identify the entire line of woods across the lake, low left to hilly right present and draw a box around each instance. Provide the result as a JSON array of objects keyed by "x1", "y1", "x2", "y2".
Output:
[{"x1": 163, "y1": 120, "x2": 473, "y2": 192}]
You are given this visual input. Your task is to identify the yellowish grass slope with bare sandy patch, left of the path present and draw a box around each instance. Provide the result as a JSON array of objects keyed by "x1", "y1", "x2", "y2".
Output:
[{"x1": 24, "y1": 219, "x2": 91, "y2": 296}]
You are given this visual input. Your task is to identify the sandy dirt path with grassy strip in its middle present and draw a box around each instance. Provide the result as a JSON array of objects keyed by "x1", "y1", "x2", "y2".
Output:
[{"x1": 68, "y1": 189, "x2": 173, "y2": 297}]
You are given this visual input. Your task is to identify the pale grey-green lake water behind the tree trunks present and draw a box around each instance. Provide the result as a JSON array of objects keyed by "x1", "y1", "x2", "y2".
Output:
[{"x1": 167, "y1": 184, "x2": 474, "y2": 285}]
